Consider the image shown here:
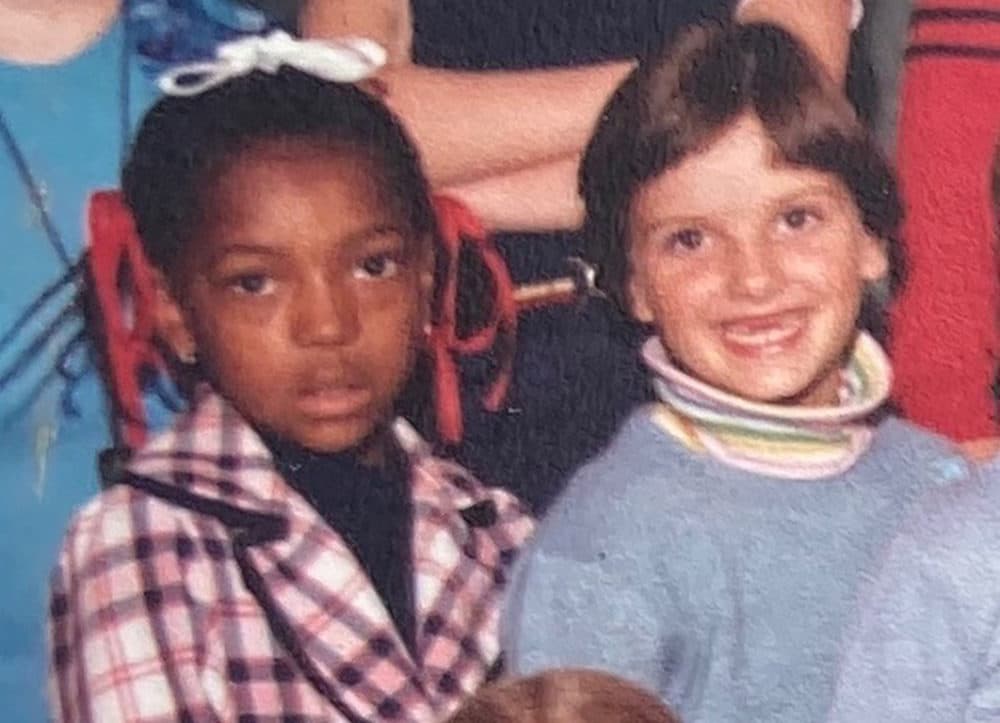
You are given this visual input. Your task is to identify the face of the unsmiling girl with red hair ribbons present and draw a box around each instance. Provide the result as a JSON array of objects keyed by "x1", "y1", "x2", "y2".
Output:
[{"x1": 163, "y1": 143, "x2": 432, "y2": 452}]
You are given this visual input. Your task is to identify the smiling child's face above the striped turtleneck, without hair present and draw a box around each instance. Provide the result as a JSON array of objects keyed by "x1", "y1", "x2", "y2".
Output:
[{"x1": 629, "y1": 116, "x2": 888, "y2": 405}]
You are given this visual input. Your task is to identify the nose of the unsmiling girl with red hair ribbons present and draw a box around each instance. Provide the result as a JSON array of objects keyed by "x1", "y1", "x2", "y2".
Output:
[{"x1": 292, "y1": 274, "x2": 361, "y2": 346}]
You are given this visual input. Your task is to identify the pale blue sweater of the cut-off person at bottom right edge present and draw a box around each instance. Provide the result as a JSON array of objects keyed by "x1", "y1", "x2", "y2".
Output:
[{"x1": 831, "y1": 460, "x2": 1000, "y2": 723}]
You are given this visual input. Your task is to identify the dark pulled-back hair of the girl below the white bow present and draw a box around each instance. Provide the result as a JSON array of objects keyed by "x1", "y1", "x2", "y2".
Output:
[{"x1": 122, "y1": 67, "x2": 436, "y2": 275}]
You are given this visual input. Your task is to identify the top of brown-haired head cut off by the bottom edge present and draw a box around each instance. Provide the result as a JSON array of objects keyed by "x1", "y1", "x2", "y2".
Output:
[{"x1": 448, "y1": 670, "x2": 678, "y2": 723}]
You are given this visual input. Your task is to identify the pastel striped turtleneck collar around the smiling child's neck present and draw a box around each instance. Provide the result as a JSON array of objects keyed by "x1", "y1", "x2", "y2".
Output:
[{"x1": 642, "y1": 332, "x2": 892, "y2": 480}]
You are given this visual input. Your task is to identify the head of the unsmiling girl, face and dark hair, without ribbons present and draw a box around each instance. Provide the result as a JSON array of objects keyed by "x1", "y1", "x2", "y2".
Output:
[{"x1": 122, "y1": 69, "x2": 435, "y2": 452}]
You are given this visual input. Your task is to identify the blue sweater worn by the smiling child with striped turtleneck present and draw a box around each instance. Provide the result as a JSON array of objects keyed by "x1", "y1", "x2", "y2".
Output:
[{"x1": 502, "y1": 409, "x2": 969, "y2": 723}]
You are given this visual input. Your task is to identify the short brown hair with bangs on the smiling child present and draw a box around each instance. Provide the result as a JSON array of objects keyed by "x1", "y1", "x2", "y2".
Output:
[{"x1": 580, "y1": 21, "x2": 904, "y2": 324}]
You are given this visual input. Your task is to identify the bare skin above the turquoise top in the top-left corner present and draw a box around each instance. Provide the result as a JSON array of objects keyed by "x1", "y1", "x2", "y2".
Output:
[{"x1": 0, "y1": 0, "x2": 121, "y2": 65}]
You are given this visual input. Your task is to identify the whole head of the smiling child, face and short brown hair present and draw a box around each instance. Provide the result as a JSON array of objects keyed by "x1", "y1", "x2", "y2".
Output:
[{"x1": 580, "y1": 25, "x2": 902, "y2": 405}]
